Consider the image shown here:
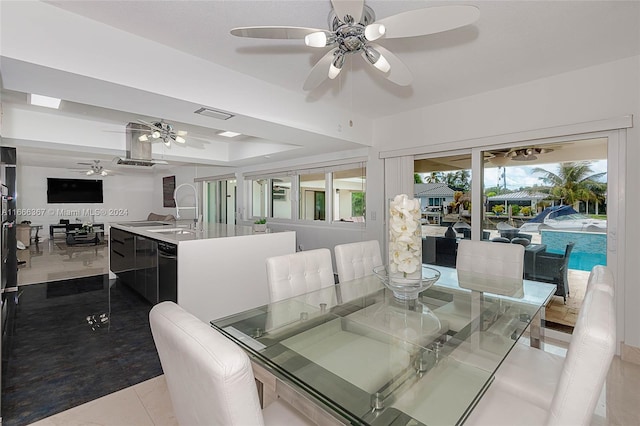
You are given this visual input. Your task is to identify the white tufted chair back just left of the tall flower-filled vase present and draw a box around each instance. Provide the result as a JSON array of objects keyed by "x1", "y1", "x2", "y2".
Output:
[{"x1": 334, "y1": 240, "x2": 382, "y2": 282}]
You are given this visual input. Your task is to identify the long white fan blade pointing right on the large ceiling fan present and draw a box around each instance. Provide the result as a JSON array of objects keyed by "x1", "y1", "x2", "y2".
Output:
[{"x1": 376, "y1": 5, "x2": 480, "y2": 38}]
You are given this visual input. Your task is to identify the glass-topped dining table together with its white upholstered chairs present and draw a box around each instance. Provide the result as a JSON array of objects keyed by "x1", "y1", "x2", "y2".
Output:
[{"x1": 150, "y1": 235, "x2": 616, "y2": 425}]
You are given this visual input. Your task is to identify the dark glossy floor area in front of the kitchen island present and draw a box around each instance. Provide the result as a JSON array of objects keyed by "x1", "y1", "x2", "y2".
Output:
[{"x1": 2, "y1": 275, "x2": 162, "y2": 426}]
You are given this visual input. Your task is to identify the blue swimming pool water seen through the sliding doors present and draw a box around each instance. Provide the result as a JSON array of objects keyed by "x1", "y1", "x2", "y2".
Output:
[{"x1": 540, "y1": 229, "x2": 607, "y2": 271}]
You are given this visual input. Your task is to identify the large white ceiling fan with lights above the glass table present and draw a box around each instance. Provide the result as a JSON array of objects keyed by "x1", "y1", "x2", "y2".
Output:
[{"x1": 231, "y1": 0, "x2": 480, "y2": 90}]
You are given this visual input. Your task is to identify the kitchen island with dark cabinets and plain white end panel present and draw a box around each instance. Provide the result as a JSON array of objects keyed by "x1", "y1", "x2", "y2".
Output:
[{"x1": 109, "y1": 221, "x2": 296, "y2": 322}]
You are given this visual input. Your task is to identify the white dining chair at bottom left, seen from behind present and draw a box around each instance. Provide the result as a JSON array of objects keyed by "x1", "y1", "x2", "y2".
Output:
[{"x1": 149, "y1": 302, "x2": 313, "y2": 426}]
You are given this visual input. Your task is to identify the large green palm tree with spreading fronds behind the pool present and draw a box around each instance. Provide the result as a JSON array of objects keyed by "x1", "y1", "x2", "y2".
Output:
[{"x1": 533, "y1": 161, "x2": 607, "y2": 205}]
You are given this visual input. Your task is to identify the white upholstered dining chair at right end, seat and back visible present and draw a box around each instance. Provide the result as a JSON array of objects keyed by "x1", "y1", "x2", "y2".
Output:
[{"x1": 465, "y1": 267, "x2": 616, "y2": 426}]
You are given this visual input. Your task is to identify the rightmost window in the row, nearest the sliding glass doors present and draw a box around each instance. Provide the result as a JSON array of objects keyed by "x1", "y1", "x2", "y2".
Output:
[{"x1": 332, "y1": 165, "x2": 366, "y2": 222}]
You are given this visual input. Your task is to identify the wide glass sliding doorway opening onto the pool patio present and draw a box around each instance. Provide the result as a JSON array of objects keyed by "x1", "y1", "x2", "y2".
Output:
[{"x1": 414, "y1": 136, "x2": 609, "y2": 334}]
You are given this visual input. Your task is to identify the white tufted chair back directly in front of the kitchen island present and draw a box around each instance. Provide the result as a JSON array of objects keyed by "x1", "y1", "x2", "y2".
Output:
[{"x1": 267, "y1": 248, "x2": 335, "y2": 303}]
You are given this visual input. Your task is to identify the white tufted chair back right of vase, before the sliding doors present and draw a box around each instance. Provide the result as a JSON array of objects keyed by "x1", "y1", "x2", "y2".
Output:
[{"x1": 456, "y1": 240, "x2": 524, "y2": 297}]
